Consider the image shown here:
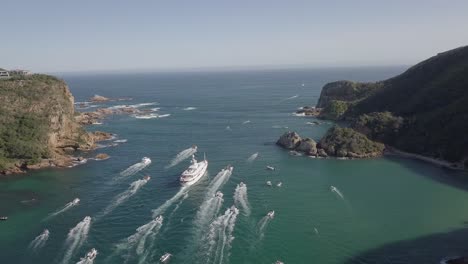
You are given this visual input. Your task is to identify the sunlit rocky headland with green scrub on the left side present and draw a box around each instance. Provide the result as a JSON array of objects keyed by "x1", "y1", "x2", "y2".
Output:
[{"x1": 0, "y1": 75, "x2": 94, "y2": 173}]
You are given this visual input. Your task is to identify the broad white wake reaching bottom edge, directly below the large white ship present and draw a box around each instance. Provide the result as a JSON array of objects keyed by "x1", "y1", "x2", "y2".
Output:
[{"x1": 200, "y1": 206, "x2": 239, "y2": 263}]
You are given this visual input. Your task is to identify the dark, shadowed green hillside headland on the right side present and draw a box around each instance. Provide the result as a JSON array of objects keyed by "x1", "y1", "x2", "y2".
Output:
[{"x1": 317, "y1": 46, "x2": 468, "y2": 167}]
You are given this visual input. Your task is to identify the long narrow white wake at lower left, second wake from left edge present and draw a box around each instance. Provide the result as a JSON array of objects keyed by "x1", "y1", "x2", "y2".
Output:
[{"x1": 62, "y1": 216, "x2": 91, "y2": 264}]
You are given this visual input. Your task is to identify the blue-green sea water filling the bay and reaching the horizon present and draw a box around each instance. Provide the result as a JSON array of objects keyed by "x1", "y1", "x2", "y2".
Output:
[{"x1": 0, "y1": 67, "x2": 468, "y2": 264}]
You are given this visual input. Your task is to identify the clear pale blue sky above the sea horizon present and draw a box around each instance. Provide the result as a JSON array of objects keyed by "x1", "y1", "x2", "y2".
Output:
[{"x1": 0, "y1": 0, "x2": 468, "y2": 72}]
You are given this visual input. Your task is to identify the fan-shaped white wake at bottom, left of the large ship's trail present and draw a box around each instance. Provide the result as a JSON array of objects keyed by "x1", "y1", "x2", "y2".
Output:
[{"x1": 115, "y1": 216, "x2": 163, "y2": 263}]
